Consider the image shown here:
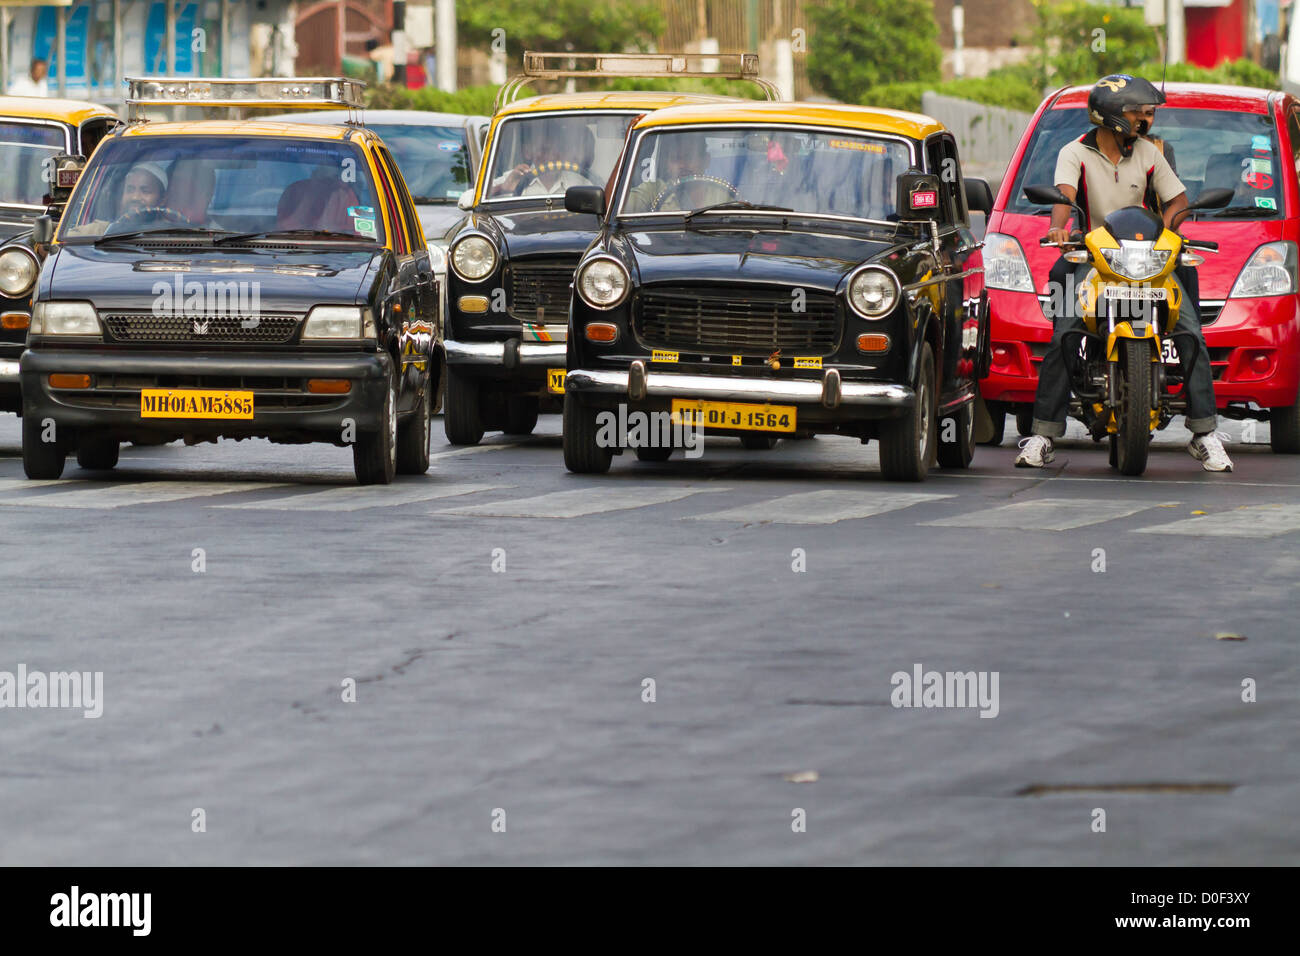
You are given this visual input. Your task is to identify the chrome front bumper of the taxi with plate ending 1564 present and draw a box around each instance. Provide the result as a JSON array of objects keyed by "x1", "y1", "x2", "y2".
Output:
[{"x1": 564, "y1": 368, "x2": 917, "y2": 408}]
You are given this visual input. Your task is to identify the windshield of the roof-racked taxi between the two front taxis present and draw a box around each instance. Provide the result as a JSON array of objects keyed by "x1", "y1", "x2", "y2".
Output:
[{"x1": 484, "y1": 111, "x2": 634, "y2": 199}]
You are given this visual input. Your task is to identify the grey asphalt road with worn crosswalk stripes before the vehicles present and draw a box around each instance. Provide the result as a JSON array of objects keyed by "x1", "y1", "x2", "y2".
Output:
[{"x1": 0, "y1": 416, "x2": 1300, "y2": 865}]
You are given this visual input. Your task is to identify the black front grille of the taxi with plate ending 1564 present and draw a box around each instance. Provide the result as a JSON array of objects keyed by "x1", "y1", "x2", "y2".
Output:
[{"x1": 634, "y1": 286, "x2": 840, "y2": 356}]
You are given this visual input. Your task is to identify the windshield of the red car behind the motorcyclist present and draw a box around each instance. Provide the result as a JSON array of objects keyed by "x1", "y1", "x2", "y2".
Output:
[{"x1": 1008, "y1": 107, "x2": 1283, "y2": 220}]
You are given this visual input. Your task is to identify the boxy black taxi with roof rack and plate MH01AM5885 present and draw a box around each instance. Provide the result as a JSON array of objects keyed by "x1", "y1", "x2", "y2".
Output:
[{"x1": 21, "y1": 79, "x2": 439, "y2": 484}]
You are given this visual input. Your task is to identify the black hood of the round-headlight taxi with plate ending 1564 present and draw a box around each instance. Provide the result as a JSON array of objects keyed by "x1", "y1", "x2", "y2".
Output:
[{"x1": 621, "y1": 228, "x2": 894, "y2": 291}]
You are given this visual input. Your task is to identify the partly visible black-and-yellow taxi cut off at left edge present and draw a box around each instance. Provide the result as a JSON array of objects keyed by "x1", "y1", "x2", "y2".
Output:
[{"x1": 0, "y1": 96, "x2": 118, "y2": 411}]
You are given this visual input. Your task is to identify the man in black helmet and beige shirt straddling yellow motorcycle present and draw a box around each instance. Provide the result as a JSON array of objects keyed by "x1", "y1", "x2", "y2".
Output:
[{"x1": 1015, "y1": 74, "x2": 1232, "y2": 471}]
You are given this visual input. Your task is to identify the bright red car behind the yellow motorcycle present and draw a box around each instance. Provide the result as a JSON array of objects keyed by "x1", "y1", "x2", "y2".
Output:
[{"x1": 980, "y1": 83, "x2": 1300, "y2": 454}]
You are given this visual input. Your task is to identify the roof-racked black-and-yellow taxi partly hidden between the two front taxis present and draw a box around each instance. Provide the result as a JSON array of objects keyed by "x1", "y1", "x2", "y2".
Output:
[{"x1": 443, "y1": 52, "x2": 775, "y2": 445}]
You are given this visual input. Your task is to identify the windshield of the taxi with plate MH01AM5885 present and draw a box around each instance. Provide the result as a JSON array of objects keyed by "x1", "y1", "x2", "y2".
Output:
[{"x1": 59, "y1": 135, "x2": 384, "y2": 242}]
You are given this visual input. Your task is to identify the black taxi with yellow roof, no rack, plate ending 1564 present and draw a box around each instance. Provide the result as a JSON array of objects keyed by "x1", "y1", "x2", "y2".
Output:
[{"x1": 564, "y1": 103, "x2": 992, "y2": 481}]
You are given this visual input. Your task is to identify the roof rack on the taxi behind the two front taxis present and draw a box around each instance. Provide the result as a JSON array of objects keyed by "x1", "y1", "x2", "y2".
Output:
[{"x1": 493, "y1": 51, "x2": 781, "y2": 112}]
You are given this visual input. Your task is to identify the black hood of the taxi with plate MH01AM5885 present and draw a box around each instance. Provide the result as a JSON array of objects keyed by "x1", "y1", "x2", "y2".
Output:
[{"x1": 40, "y1": 245, "x2": 384, "y2": 312}]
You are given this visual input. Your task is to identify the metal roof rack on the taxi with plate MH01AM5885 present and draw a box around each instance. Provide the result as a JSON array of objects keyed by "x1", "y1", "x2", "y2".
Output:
[{"x1": 124, "y1": 77, "x2": 365, "y2": 125}]
